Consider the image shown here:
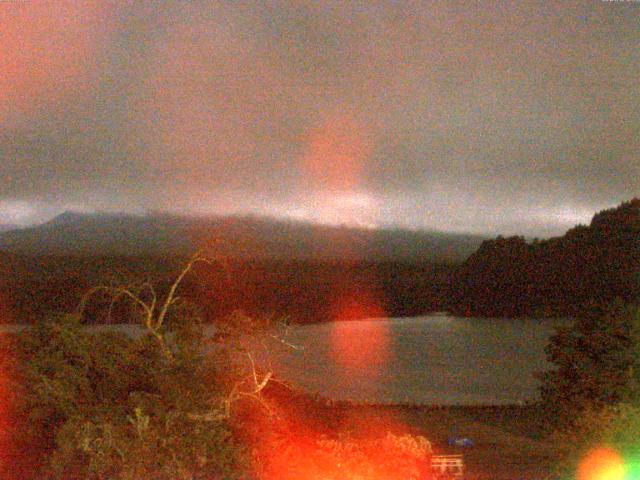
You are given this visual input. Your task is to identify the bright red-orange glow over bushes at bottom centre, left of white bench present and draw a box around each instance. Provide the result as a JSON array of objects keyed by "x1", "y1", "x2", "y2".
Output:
[{"x1": 248, "y1": 372, "x2": 431, "y2": 480}]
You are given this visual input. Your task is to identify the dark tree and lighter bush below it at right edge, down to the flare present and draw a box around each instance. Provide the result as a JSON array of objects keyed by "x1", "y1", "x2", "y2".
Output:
[{"x1": 540, "y1": 300, "x2": 640, "y2": 478}]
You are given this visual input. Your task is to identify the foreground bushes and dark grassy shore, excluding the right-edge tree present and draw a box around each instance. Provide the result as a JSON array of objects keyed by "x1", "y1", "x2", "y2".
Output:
[{"x1": 0, "y1": 317, "x2": 561, "y2": 480}]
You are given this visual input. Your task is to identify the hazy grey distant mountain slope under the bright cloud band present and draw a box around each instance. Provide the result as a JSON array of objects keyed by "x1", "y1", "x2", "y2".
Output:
[{"x1": 0, "y1": 212, "x2": 483, "y2": 262}]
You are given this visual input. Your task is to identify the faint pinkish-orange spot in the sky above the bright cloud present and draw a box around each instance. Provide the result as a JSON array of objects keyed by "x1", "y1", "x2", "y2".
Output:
[{"x1": 302, "y1": 115, "x2": 370, "y2": 191}]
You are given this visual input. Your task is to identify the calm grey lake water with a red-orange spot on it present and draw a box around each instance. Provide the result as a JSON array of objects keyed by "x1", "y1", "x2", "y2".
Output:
[{"x1": 0, "y1": 315, "x2": 567, "y2": 405}]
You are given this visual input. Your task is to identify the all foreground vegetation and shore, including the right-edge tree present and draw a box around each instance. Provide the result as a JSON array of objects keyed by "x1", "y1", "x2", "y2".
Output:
[{"x1": 0, "y1": 276, "x2": 640, "y2": 480}]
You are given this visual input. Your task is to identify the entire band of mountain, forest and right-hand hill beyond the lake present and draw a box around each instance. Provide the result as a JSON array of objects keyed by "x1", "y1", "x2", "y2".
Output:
[{"x1": 0, "y1": 198, "x2": 640, "y2": 322}]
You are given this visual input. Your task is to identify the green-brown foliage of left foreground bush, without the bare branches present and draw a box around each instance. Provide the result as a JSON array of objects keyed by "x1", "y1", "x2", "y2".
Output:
[{"x1": 15, "y1": 317, "x2": 248, "y2": 480}]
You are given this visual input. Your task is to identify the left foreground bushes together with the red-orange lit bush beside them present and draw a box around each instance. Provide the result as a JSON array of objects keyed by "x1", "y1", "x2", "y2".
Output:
[{"x1": 0, "y1": 312, "x2": 431, "y2": 480}]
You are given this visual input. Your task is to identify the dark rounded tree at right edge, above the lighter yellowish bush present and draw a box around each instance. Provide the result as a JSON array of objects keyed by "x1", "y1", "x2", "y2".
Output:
[{"x1": 540, "y1": 300, "x2": 640, "y2": 427}]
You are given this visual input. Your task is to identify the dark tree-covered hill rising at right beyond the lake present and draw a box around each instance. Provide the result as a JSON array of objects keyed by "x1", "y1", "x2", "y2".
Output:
[{"x1": 449, "y1": 198, "x2": 640, "y2": 317}]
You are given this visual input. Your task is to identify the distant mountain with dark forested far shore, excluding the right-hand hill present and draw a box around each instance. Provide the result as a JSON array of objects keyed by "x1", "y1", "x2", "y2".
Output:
[{"x1": 0, "y1": 212, "x2": 483, "y2": 323}]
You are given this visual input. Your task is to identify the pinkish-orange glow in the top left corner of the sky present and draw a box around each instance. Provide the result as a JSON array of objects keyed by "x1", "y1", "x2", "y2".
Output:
[{"x1": 0, "y1": 1, "x2": 107, "y2": 123}]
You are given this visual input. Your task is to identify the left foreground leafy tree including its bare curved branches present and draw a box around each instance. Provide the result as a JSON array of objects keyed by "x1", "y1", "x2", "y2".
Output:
[{"x1": 7, "y1": 255, "x2": 284, "y2": 480}]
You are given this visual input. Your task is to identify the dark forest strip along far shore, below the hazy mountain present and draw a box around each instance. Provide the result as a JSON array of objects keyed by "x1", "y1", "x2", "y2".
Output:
[{"x1": 0, "y1": 254, "x2": 455, "y2": 323}]
